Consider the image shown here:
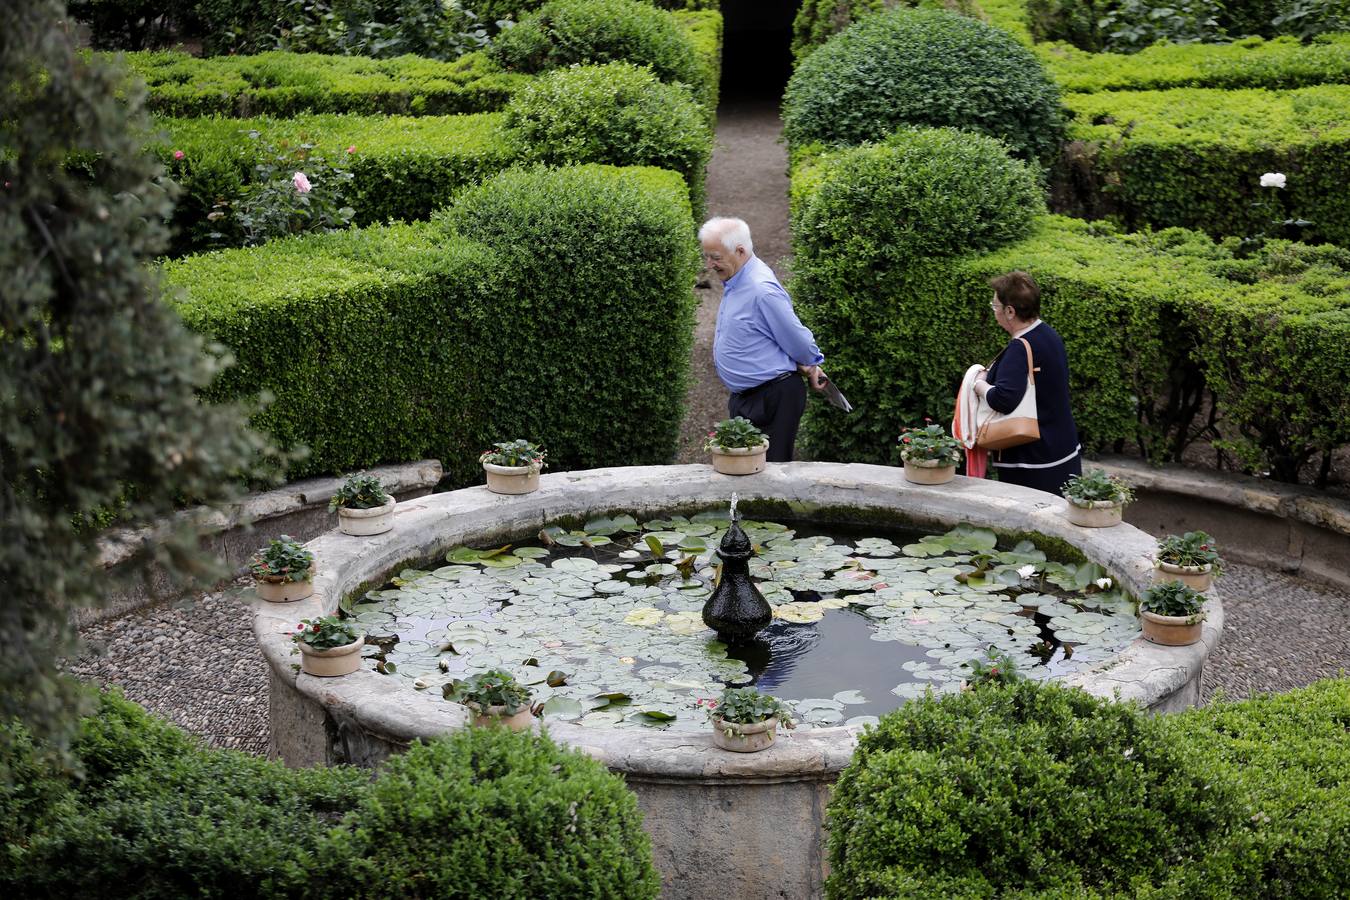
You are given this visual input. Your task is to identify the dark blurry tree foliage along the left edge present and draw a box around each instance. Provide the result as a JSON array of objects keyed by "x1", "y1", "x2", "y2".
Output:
[{"x1": 0, "y1": 0, "x2": 271, "y2": 784}]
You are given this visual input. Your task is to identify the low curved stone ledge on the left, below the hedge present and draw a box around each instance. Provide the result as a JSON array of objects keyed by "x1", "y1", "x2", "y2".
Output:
[{"x1": 85, "y1": 459, "x2": 443, "y2": 626}]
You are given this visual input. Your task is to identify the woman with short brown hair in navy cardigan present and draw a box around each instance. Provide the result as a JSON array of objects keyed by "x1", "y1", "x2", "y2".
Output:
[{"x1": 975, "y1": 271, "x2": 1083, "y2": 494}]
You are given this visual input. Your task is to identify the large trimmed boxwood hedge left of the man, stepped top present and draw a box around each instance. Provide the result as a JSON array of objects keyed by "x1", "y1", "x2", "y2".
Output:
[{"x1": 165, "y1": 166, "x2": 698, "y2": 484}]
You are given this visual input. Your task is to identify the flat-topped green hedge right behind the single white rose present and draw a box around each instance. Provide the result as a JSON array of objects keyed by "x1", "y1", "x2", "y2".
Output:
[{"x1": 1056, "y1": 85, "x2": 1350, "y2": 244}]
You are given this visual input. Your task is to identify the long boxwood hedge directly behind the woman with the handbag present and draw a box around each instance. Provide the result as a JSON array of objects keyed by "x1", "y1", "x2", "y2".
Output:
[{"x1": 791, "y1": 141, "x2": 1350, "y2": 480}]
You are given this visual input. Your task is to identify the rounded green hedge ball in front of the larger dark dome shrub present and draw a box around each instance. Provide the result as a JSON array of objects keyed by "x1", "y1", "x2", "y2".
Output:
[{"x1": 792, "y1": 128, "x2": 1045, "y2": 269}]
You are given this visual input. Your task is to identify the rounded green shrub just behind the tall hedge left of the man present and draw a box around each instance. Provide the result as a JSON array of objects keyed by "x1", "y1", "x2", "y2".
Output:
[{"x1": 505, "y1": 62, "x2": 713, "y2": 210}]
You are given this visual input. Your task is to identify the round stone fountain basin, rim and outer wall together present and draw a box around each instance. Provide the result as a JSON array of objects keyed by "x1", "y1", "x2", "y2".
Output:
[{"x1": 254, "y1": 463, "x2": 1223, "y2": 897}]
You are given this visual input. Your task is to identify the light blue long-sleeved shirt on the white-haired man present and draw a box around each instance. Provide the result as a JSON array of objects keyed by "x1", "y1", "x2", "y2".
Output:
[{"x1": 713, "y1": 256, "x2": 825, "y2": 393}]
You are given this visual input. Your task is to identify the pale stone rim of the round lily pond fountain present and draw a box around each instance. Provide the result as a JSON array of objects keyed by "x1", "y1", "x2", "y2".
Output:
[{"x1": 246, "y1": 463, "x2": 1223, "y2": 783}]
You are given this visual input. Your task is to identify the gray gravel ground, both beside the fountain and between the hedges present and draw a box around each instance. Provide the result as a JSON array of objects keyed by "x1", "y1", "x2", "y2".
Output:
[{"x1": 73, "y1": 103, "x2": 1350, "y2": 753}]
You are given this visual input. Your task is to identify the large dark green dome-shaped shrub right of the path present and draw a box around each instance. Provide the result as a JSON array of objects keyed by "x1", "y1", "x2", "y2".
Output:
[{"x1": 783, "y1": 9, "x2": 1061, "y2": 161}]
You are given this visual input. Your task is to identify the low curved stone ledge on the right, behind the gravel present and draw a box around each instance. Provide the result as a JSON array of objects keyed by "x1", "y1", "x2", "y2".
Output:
[{"x1": 1099, "y1": 456, "x2": 1350, "y2": 590}]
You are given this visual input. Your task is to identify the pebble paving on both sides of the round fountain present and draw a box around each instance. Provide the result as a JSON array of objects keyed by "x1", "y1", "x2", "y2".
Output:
[{"x1": 73, "y1": 565, "x2": 1350, "y2": 754}]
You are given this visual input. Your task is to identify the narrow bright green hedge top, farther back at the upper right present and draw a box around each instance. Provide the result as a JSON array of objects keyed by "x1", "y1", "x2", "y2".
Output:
[{"x1": 1037, "y1": 34, "x2": 1350, "y2": 93}]
